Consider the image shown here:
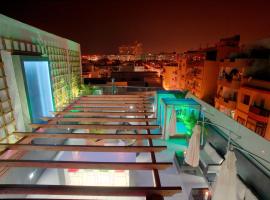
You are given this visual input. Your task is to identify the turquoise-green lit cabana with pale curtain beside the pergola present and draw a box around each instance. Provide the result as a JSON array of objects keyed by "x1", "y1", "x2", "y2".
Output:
[{"x1": 160, "y1": 98, "x2": 201, "y2": 139}]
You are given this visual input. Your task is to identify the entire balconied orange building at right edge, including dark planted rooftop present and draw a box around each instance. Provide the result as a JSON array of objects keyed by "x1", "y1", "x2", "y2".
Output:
[{"x1": 215, "y1": 42, "x2": 269, "y2": 139}]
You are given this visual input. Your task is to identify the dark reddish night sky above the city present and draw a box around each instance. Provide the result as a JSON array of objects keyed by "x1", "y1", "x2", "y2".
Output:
[{"x1": 0, "y1": 0, "x2": 270, "y2": 53}]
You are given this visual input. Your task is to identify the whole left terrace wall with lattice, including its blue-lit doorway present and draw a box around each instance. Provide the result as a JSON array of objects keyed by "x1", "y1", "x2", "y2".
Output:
[{"x1": 0, "y1": 15, "x2": 81, "y2": 136}]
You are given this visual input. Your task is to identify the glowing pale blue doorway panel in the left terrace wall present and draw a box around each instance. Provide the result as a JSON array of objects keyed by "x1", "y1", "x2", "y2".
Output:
[{"x1": 24, "y1": 61, "x2": 54, "y2": 123}]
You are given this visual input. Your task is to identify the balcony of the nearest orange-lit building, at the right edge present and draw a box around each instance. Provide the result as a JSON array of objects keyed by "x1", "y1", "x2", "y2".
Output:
[{"x1": 248, "y1": 106, "x2": 270, "y2": 124}]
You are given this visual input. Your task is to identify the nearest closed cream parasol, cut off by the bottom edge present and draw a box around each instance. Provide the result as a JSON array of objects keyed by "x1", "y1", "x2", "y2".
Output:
[{"x1": 212, "y1": 150, "x2": 237, "y2": 200}]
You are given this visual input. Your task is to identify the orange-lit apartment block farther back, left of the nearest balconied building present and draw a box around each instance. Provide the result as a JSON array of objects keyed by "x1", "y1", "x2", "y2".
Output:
[{"x1": 163, "y1": 49, "x2": 218, "y2": 102}]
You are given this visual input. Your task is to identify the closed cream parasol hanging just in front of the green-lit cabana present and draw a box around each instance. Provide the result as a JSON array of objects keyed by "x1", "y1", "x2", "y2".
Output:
[{"x1": 185, "y1": 124, "x2": 201, "y2": 167}]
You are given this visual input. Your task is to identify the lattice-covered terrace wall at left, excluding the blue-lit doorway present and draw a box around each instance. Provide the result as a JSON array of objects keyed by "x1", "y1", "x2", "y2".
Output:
[{"x1": 0, "y1": 14, "x2": 81, "y2": 134}]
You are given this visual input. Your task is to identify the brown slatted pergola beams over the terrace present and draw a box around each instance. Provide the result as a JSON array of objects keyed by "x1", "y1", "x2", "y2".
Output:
[{"x1": 0, "y1": 95, "x2": 182, "y2": 200}]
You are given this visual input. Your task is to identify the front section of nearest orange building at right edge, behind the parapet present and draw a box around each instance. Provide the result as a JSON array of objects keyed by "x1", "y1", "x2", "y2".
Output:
[{"x1": 234, "y1": 80, "x2": 270, "y2": 140}]
